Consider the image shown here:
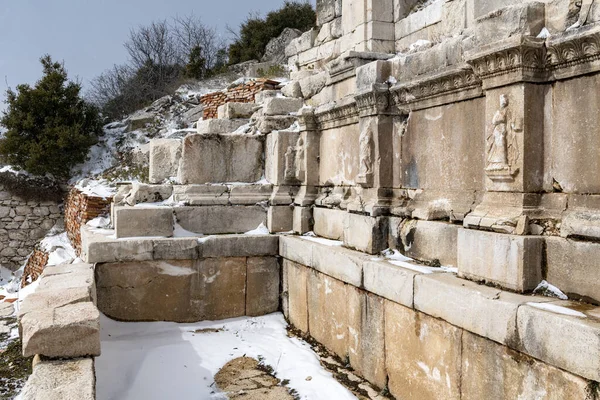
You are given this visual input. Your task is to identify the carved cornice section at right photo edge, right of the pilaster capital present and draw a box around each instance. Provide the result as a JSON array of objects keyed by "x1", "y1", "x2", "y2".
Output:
[{"x1": 546, "y1": 25, "x2": 600, "y2": 79}]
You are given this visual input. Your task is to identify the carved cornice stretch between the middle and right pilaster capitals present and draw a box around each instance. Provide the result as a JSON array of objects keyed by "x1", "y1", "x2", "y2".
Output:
[{"x1": 391, "y1": 66, "x2": 482, "y2": 110}]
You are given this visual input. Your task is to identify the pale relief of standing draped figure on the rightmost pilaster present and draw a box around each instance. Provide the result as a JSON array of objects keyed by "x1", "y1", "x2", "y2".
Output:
[{"x1": 485, "y1": 94, "x2": 523, "y2": 179}]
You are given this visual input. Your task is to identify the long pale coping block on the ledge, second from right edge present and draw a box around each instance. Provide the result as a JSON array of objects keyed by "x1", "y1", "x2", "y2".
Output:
[{"x1": 414, "y1": 274, "x2": 552, "y2": 344}]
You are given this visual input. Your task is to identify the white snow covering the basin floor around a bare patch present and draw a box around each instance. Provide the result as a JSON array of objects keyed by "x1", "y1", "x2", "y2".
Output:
[{"x1": 96, "y1": 313, "x2": 356, "y2": 400}]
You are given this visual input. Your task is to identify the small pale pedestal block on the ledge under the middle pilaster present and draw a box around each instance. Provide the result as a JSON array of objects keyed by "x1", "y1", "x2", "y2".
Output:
[{"x1": 344, "y1": 213, "x2": 388, "y2": 254}]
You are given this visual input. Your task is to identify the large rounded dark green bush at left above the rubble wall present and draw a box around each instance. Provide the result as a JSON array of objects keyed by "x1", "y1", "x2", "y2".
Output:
[{"x1": 0, "y1": 55, "x2": 102, "y2": 179}]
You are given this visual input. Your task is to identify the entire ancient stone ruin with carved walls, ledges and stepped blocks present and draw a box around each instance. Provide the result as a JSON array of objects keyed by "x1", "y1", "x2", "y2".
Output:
[{"x1": 14, "y1": 0, "x2": 600, "y2": 399}]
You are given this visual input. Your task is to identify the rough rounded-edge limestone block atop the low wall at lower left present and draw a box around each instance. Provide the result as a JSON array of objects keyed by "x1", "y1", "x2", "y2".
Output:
[{"x1": 19, "y1": 302, "x2": 100, "y2": 358}]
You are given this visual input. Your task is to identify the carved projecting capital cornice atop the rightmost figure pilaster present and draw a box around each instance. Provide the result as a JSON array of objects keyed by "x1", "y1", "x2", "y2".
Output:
[{"x1": 466, "y1": 36, "x2": 548, "y2": 89}]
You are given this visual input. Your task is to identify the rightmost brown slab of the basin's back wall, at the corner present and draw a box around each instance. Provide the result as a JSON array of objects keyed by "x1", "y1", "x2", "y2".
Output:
[{"x1": 246, "y1": 257, "x2": 281, "y2": 317}]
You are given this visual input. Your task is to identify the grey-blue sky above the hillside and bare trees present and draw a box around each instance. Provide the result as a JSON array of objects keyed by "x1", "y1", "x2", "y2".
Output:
[{"x1": 0, "y1": 0, "x2": 315, "y2": 103}]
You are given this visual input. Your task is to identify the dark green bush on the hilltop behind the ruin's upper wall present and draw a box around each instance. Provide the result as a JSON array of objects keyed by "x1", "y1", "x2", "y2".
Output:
[{"x1": 229, "y1": 1, "x2": 317, "y2": 65}]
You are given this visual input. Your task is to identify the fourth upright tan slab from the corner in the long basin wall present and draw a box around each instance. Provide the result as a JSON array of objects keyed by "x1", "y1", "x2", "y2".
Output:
[{"x1": 385, "y1": 300, "x2": 462, "y2": 400}]
